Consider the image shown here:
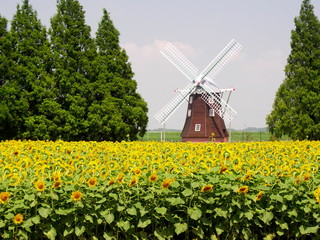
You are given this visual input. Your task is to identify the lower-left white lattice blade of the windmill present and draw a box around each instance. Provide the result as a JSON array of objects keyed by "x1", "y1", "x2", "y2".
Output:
[{"x1": 155, "y1": 83, "x2": 196, "y2": 124}]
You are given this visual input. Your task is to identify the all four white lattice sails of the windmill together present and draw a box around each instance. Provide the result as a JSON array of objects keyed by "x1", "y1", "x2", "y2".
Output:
[{"x1": 155, "y1": 40, "x2": 242, "y2": 127}]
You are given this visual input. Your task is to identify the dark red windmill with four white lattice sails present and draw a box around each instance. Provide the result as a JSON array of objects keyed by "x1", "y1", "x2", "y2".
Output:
[{"x1": 155, "y1": 40, "x2": 242, "y2": 142}]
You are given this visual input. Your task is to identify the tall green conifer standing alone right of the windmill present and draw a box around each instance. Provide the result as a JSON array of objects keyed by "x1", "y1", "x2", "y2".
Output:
[{"x1": 266, "y1": 0, "x2": 320, "y2": 140}]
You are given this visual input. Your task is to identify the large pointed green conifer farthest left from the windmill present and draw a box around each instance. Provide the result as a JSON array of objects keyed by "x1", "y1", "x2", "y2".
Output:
[{"x1": 0, "y1": 0, "x2": 52, "y2": 139}]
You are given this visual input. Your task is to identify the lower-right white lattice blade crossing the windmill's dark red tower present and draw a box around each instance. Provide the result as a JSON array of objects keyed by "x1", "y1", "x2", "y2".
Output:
[{"x1": 201, "y1": 84, "x2": 237, "y2": 124}]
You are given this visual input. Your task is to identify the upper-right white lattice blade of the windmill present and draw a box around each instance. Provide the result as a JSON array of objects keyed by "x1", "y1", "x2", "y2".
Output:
[{"x1": 200, "y1": 39, "x2": 242, "y2": 79}]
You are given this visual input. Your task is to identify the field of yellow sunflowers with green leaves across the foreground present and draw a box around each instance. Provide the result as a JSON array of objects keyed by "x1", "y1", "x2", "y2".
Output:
[{"x1": 0, "y1": 141, "x2": 320, "y2": 240}]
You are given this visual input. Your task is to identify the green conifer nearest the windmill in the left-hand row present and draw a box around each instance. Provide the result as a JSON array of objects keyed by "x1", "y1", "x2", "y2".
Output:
[{"x1": 96, "y1": 9, "x2": 148, "y2": 140}]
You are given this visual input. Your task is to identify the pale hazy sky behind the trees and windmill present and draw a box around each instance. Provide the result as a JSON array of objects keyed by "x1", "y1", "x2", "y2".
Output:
[{"x1": 0, "y1": 0, "x2": 320, "y2": 129}]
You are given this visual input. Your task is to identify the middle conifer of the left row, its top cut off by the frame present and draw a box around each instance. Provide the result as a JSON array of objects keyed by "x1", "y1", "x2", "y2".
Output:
[{"x1": 50, "y1": 0, "x2": 96, "y2": 140}]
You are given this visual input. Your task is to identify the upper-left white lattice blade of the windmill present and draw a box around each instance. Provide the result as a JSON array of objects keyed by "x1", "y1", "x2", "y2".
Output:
[{"x1": 160, "y1": 42, "x2": 198, "y2": 81}]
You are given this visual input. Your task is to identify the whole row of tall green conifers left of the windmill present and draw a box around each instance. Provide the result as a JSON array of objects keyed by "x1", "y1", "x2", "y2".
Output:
[{"x1": 0, "y1": 0, "x2": 148, "y2": 141}]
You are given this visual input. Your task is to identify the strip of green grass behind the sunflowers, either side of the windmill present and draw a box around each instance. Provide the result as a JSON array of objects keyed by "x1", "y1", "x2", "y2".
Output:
[{"x1": 139, "y1": 131, "x2": 289, "y2": 142}]
